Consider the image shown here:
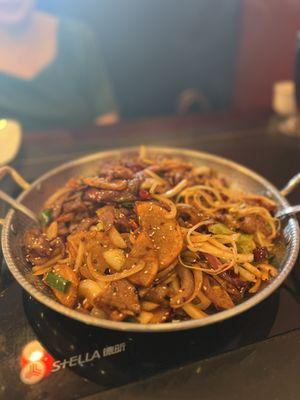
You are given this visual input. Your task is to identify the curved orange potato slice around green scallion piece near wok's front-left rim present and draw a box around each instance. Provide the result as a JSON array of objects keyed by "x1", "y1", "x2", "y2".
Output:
[{"x1": 51, "y1": 264, "x2": 79, "y2": 308}]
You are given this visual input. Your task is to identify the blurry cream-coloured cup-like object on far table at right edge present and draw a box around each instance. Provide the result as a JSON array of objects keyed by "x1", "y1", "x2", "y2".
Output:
[{"x1": 273, "y1": 81, "x2": 297, "y2": 115}]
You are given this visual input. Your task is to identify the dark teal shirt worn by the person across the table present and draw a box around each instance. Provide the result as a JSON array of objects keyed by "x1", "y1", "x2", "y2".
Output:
[{"x1": 0, "y1": 20, "x2": 116, "y2": 127}]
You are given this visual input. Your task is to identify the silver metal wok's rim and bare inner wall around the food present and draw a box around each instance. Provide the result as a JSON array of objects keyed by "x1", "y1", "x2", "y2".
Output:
[{"x1": 2, "y1": 147, "x2": 300, "y2": 332}]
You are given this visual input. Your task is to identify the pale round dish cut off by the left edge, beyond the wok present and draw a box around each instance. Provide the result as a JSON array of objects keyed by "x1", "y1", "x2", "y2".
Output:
[{"x1": 0, "y1": 119, "x2": 22, "y2": 165}]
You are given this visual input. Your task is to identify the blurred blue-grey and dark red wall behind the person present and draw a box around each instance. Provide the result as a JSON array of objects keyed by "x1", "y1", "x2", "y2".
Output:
[{"x1": 38, "y1": 0, "x2": 300, "y2": 118}]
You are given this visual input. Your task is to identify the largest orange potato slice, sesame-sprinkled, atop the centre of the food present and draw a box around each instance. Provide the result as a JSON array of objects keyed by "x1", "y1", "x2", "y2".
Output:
[{"x1": 136, "y1": 201, "x2": 183, "y2": 270}]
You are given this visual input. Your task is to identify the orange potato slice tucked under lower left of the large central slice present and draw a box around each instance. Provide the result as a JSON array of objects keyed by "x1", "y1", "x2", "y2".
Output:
[{"x1": 125, "y1": 232, "x2": 158, "y2": 287}]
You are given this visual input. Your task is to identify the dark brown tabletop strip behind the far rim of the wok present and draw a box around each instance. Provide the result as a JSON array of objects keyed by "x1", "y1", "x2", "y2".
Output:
[{"x1": 13, "y1": 110, "x2": 300, "y2": 203}]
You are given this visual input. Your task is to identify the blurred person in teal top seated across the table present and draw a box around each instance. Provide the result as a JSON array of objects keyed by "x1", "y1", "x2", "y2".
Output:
[{"x1": 0, "y1": 0, "x2": 119, "y2": 126}]
